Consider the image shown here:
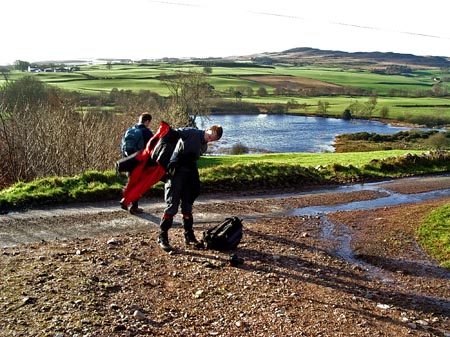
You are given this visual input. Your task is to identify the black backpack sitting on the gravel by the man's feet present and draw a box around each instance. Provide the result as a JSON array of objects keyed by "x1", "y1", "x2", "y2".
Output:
[{"x1": 203, "y1": 216, "x2": 243, "y2": 251}]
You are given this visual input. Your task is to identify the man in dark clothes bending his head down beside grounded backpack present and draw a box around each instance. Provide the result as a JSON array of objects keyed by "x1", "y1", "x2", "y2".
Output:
[{"x1": 157, "y1": 125, "x2": 223, "y2": 252}]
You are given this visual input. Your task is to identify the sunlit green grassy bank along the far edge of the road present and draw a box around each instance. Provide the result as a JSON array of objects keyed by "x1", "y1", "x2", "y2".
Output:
[{"x1": 0, "y1": 150, "x2": 450, "y2": 213}]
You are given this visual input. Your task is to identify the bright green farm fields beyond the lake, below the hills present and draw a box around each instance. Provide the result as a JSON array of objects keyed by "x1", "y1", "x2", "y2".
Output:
[{"x1": 0, "y1": 63, "x2": 450, "y2": 119}]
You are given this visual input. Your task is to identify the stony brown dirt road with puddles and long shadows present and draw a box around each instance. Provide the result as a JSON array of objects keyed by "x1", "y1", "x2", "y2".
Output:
[{"x1": 0, "y1": 176, "x2": 450, "y2": 336}]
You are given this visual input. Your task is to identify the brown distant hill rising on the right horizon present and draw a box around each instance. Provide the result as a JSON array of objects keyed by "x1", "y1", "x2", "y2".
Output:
[{"x1": 237, "y1": 47, "x2": 450, "y2": 68}]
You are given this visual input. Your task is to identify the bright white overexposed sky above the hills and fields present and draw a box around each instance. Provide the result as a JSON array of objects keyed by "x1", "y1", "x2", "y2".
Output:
[{"x1": 0, "y1": 0, "x2": 450, "y2": 65}]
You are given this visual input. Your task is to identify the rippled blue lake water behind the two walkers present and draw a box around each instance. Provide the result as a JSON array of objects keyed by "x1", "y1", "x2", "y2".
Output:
[{"x1": 198, "y1": 114, "x2": 428, "y2": 153}]
